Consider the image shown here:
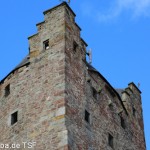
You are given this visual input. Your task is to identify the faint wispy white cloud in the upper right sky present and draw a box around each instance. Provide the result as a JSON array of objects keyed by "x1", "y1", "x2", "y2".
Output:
[{"x1": 81, "y1": 0, "x2": 150, "y2": 22}]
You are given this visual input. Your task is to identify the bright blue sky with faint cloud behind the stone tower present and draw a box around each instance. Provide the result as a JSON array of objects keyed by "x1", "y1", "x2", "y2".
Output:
[{"x1": 0, "y1": 0, "x2": 150, "y2": 150}]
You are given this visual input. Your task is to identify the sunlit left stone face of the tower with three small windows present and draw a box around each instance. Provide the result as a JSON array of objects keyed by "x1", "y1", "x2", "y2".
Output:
[{"x1": 0, "y1": 4, "x2": 68, "y2": 150}]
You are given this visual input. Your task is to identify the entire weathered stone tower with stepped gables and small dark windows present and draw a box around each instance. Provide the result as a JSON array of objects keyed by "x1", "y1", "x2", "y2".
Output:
[{"x1": 0, "y1": 2, "x2": 146, "y2": 150}]
